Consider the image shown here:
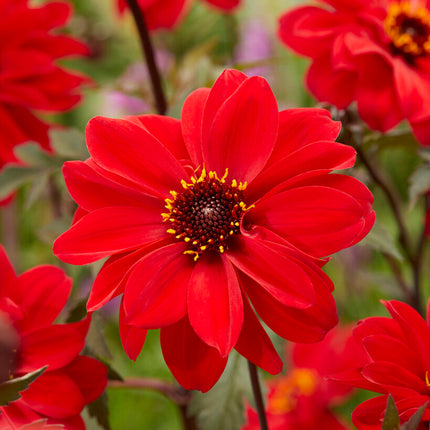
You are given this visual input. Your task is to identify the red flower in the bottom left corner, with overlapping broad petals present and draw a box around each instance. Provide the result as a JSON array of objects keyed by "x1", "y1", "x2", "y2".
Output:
[{"x1": 0, "y1": 247, "x2": 107, "y2": 430}]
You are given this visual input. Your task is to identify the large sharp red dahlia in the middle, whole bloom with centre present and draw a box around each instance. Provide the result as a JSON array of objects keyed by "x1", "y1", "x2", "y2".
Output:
[{"x1": 54, "y1": 70, "x2": 374, "y2": 391}]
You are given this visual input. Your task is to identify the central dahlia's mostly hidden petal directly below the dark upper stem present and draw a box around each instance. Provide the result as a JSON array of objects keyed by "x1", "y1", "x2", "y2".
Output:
[{"x1": 125, "y1": 115, "x2": 190, "y2": 160}]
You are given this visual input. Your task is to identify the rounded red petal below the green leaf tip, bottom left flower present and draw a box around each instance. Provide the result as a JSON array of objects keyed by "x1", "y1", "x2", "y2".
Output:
[{"x1": 21, "y1": 370, "x2": 85, "y2": 418}]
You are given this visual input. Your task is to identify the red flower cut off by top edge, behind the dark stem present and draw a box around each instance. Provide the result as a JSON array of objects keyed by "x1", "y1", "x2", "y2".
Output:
[{"x1": 118, "y1": 0, "x2": 240, "y2": 30}]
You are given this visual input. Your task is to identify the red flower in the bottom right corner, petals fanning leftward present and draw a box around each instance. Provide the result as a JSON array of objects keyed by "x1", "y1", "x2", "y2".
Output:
[{"x1": 337, "y1": 300, "x2": 430, "y2": 430}]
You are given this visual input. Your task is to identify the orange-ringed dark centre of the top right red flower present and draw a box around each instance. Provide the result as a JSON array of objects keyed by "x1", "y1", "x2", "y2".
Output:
[{"x1": 384, "y1": 1, "x2": 430, "y2": 61}]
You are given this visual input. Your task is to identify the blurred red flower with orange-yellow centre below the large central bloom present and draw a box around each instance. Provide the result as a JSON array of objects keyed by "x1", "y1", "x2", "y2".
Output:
[{"x1": 242, "y1": 326, "x2": 364, "y2": 430}]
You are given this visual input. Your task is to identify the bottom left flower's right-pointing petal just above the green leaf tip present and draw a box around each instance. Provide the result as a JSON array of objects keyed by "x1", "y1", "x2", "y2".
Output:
[{"x1": 19, "y1": 323, "x2": 85, "y2": 372}]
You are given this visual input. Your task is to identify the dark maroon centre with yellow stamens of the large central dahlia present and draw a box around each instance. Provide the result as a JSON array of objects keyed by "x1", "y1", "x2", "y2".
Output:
[{"x1": 162, "y1": 169, "x2": 252, "y2": 261}]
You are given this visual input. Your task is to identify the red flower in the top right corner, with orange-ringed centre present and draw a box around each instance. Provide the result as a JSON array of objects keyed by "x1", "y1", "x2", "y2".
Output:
[{"x1": 279, "y1": 0, "x2": 430, "y2": 145}]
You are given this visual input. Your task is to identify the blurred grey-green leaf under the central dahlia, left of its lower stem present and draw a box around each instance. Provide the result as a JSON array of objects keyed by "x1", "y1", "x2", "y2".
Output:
[{"x1": 189, "y1": 352, "x2": 252, "y2": 430}]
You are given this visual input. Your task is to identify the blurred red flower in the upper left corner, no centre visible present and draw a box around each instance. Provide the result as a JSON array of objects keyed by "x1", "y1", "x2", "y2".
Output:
[{"x1": 0, "y1": 0, "x2": 88, "y2": 168}]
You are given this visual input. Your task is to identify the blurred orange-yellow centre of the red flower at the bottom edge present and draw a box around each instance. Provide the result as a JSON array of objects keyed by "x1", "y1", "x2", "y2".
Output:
[{"x1": 268, "y1": 368, "x2": 319, "y2": 414}]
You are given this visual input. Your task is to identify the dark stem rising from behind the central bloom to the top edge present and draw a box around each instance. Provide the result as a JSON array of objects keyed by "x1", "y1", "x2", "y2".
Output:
[{"x1": 127, "y1": 0, "x2": 167, "y2": 115}]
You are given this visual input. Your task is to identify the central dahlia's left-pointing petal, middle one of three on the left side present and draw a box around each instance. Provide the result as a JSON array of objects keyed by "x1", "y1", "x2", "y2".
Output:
[{"x1": 63, "y1": 161, "x2": 159, "y2": 212}]
